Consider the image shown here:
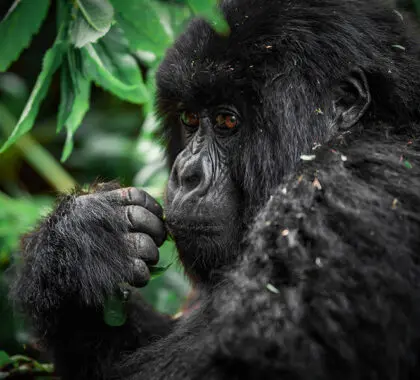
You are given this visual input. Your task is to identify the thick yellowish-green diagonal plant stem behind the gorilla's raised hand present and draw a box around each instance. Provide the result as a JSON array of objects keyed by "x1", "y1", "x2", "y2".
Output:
[{"x1": 0, "y1": 103, "x2": 77, "y2": 192}]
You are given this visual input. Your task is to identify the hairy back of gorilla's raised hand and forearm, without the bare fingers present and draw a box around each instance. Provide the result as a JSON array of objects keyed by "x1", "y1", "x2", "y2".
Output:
[{"x1": 12, "y1": 191, "x2": 173, "y2": 380}]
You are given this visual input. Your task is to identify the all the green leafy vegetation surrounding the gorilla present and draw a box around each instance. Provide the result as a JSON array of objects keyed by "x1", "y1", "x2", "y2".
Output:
[{"x1": 0, "y1": 0, "x2": 420, "y2": 379}]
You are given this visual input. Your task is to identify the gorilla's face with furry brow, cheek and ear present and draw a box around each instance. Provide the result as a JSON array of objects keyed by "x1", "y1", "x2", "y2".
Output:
[{"x1": 157, "y1": 11, "x2": 370, "y2": 282}]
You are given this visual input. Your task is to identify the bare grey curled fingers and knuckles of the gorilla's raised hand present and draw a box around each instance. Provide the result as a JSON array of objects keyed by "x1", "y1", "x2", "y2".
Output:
[{"x1": 75, "y1": 187, "x2": 166, "y2": 287}]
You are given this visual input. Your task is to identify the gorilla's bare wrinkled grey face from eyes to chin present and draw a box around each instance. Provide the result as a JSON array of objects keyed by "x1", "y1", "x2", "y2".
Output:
[{"x1": 165, "y1": 106, "x2": 243, "y2": 282}]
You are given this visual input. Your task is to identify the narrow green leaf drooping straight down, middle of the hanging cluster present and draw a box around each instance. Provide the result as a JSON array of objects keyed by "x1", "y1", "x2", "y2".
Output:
[{"x1": 57, "y1": 49, "x2": 90, "y2": 162}]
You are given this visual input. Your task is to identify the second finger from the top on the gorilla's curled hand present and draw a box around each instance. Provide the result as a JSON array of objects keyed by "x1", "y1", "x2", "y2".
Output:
[{"x1": 124, "y1": 206, "x2": 166, "y2": 247}]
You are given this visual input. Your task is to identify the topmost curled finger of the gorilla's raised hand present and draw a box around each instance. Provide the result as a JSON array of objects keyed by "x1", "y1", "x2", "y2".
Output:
[{"x1": 105, "y1": 187, "x2": 163, "y2": 218}]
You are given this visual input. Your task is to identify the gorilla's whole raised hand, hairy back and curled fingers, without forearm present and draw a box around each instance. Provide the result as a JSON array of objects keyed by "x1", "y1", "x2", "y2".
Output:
[{"x1": 14, "y1": 184, "x2": 166, "y2": 312}]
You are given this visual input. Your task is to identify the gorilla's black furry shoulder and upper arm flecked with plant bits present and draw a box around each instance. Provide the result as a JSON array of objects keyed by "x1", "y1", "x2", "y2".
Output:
[{"x1": 118, "y1": 125, "x2": 420, "y2": 380}]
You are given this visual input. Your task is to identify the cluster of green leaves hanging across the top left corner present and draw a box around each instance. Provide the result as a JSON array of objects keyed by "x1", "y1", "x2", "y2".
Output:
[{"x1": 0, "y1": 0, "x2": 229, "y2": 161}]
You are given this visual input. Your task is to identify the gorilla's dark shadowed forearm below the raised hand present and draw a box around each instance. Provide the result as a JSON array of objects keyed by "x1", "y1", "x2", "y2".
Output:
[{"x1": 48, "y1": 297, "x2": 175, "y2": 380}]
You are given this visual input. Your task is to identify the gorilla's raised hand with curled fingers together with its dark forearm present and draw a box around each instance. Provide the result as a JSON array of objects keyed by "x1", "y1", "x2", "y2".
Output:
[{"x1": 12, "y1": 183, "x2": 172, "y2": 379}]
